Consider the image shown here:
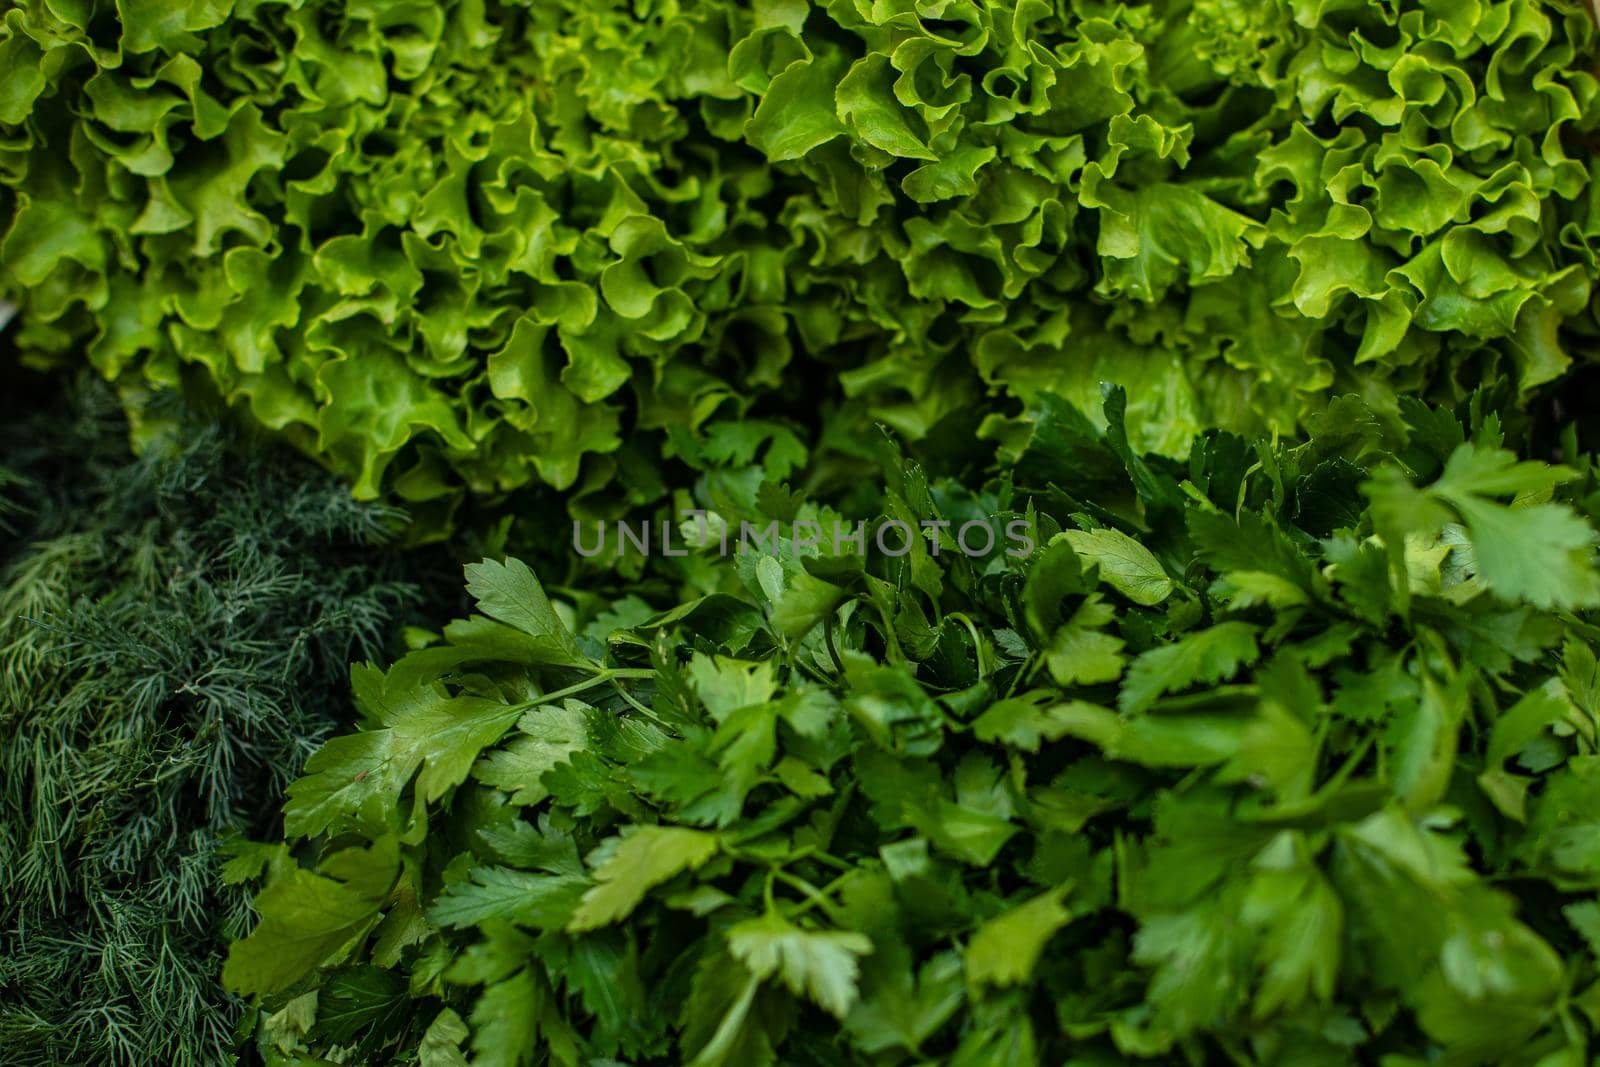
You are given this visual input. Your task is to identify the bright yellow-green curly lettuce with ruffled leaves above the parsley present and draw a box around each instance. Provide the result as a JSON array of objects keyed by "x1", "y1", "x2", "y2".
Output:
[{"x1": 0, "y1": 0, "x2": 1600, "y2": 531}]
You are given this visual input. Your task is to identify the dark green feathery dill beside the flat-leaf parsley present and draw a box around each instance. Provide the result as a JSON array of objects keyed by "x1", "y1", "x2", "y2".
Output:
[{"x1": 0, "y1": 386, "x2": 427, "y2": 1067}]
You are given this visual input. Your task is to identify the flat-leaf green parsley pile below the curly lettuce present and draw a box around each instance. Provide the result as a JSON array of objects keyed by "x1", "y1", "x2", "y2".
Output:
[{"x1": 226, "y1": 388, "x2": 1600, "y2": 1067}]
